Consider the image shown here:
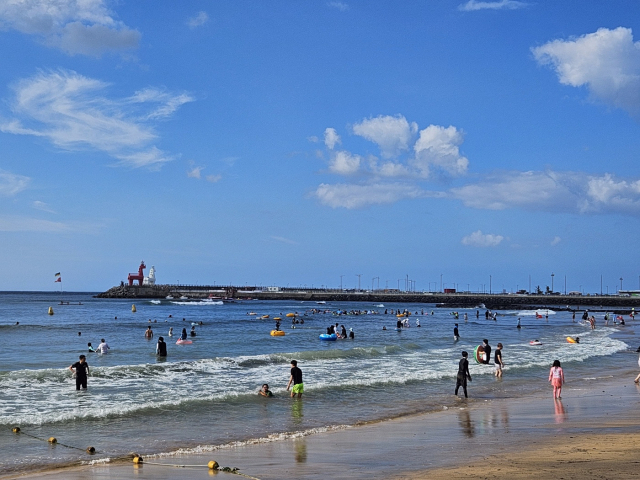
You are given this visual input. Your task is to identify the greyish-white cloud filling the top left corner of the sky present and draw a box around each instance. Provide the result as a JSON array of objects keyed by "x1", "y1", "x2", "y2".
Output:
[{"x1": 0, "y1": 0, "x2": 140, "y2": 56}]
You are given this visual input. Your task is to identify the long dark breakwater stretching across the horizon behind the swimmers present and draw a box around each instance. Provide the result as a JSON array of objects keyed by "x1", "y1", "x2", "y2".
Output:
[{"x1": 97, "y1": 285, "x2": 640, "y2": 310}]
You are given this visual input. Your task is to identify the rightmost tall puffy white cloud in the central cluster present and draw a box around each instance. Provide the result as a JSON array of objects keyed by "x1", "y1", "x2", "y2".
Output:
[{"x1": 410, "y1": 125, "x2": 469, "y2": 178}]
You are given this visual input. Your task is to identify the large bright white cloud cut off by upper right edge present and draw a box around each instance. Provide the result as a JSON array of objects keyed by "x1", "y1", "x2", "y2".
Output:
[{"x1": 532, "y1": 27, "x2": 640, "y2": 114}]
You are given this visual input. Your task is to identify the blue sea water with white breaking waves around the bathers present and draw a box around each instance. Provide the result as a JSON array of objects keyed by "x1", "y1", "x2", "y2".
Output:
[{"x1": 0, "y1": 293, "x2": 638, "y2": 474}]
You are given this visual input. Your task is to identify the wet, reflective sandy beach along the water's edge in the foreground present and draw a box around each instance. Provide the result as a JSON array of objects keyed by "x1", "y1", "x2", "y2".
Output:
[{"x1": 8, "y1": 373, "x2": 640, "y2": 480}]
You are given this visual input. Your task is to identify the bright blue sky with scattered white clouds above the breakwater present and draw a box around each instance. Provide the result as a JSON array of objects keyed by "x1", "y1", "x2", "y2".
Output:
[{"x1": 0, "y1": 0, "x2": 640, "y2": 292}]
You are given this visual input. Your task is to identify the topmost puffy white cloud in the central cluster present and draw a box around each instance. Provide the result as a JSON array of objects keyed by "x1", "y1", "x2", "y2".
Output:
[{"x1": 353, "y1": 115, "x2": 418, "y2": 158}]
